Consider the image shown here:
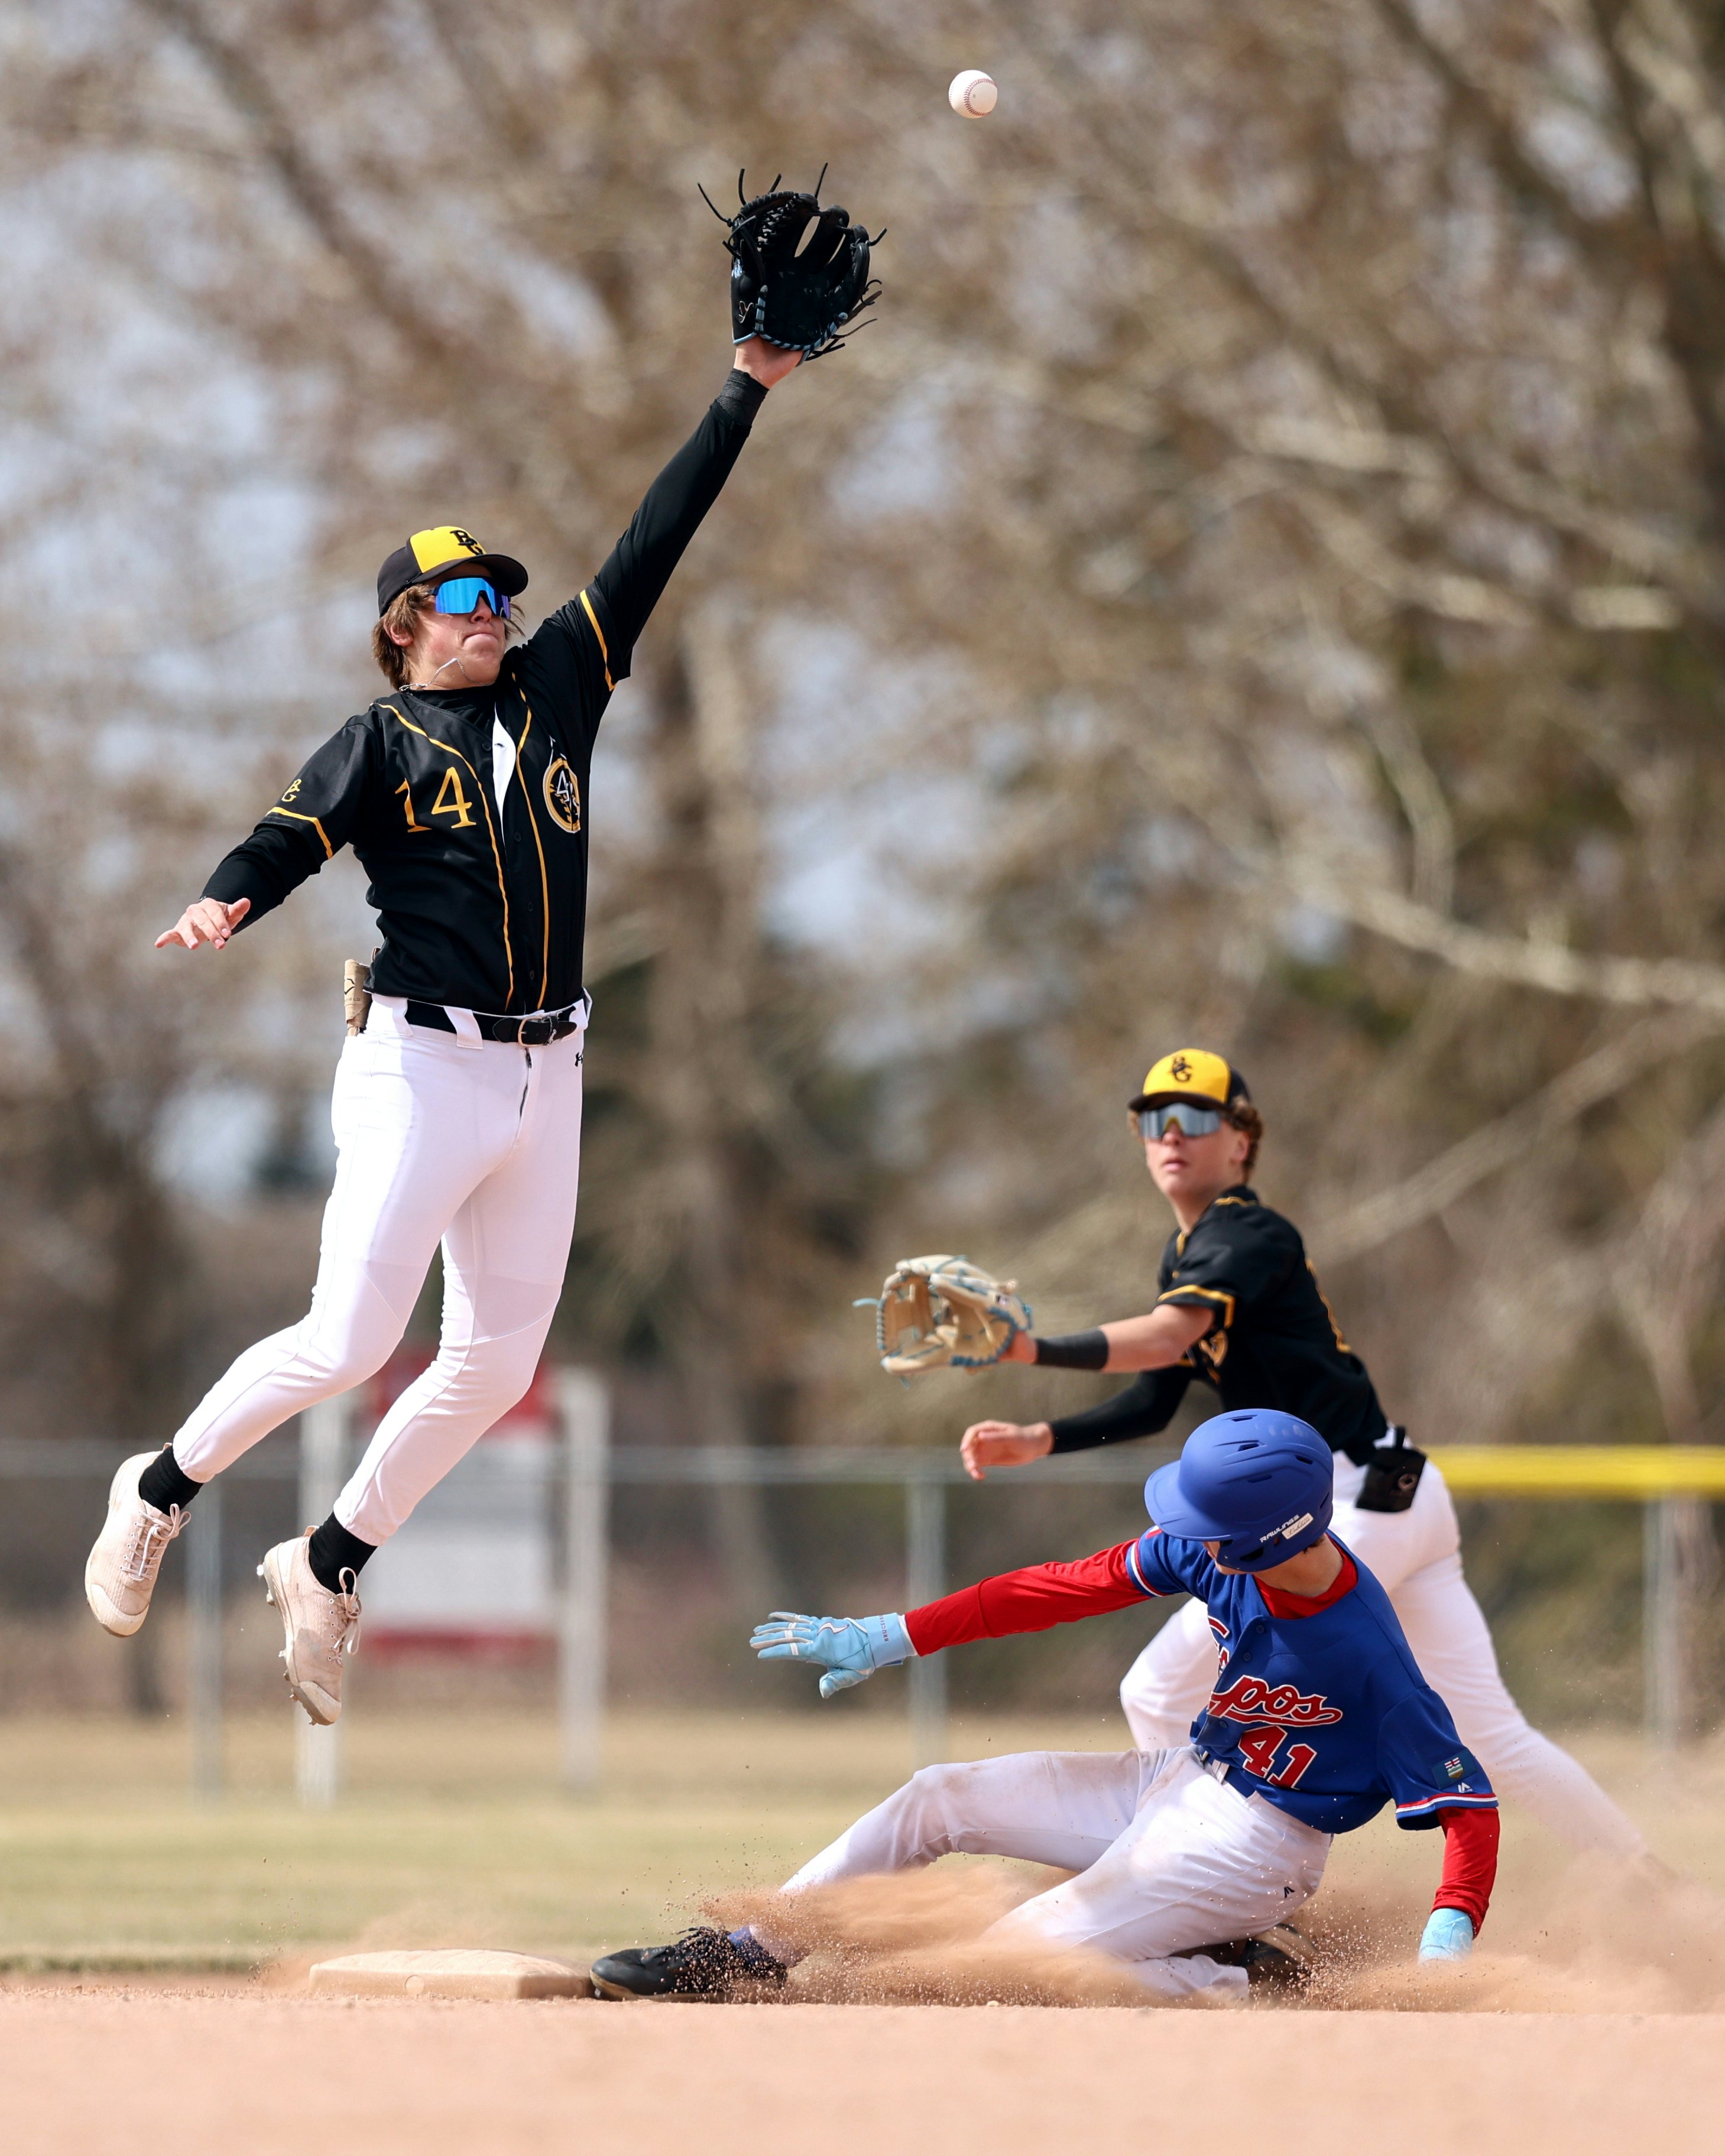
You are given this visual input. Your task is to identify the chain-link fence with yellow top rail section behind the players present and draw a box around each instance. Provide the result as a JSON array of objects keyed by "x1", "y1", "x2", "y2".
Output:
[{"x1": 0, "y1": 1371, "x2": 1725, "y2": 1804}]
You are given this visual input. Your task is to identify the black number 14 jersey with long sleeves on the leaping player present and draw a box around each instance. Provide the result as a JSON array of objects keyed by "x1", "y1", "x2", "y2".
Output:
[{"x1": 205, "y1": 371, "x2": 766, "y2": 1014}]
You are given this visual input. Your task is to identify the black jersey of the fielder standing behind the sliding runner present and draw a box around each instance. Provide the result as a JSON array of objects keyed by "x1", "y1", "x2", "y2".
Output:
[{"x1": 1052, "y1": 1184, "x2": 1386, "y2": 1464}]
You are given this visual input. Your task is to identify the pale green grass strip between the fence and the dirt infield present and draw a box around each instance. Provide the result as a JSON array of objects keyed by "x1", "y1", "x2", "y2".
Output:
[{"x1": 0, "y1": 1712, "x2": 1725, "y2": 1969}]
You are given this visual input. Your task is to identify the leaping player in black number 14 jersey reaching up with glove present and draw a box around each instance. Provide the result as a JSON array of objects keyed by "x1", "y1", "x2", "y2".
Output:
[{"x1": 84, "y1": 192, "x2": 869, "y2": 1723}]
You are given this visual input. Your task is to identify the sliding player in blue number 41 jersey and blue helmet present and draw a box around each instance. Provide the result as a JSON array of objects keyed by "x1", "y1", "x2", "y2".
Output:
[{"x1": 591, "y1": 1408, "x2": 1499, "y2": 1999}]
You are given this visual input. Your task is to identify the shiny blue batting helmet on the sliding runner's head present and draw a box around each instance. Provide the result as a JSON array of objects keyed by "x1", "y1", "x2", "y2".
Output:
[{"x1": 1145, "y1": 1408, "x2": 1335, "y2": 1571}]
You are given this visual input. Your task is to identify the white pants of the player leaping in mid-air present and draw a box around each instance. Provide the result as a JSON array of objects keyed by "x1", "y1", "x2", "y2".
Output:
[{"x1": 174, "y1": 1001, "x2": 584, "y2": 1541}]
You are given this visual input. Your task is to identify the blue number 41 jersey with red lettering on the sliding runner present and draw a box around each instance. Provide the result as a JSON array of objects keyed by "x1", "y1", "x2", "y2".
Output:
[{"x1": 1126, "y1": 1527, "x2": 1496, "y2": 1834}]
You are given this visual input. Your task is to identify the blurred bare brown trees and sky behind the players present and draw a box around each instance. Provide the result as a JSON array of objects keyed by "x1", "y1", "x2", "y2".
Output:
[{"x1": 0, "y1": 0, "x2": 1725, "y2": 1716}]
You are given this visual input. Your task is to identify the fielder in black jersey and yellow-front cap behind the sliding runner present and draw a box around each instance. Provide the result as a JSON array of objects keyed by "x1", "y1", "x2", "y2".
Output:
[{"x1": 962, "y1": 1048, "x2": 1648, "y2": 1860}]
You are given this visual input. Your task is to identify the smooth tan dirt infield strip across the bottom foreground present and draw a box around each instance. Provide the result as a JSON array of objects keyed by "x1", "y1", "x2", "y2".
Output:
[{"x1": 13, "y1": 1986, "x2": 1725, "y2": 2156}]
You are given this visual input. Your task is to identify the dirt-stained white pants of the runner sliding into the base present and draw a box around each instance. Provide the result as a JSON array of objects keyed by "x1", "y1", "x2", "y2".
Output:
[{"x1": 755, "y1": 1744, "x2": 1331, "y2": 1999}]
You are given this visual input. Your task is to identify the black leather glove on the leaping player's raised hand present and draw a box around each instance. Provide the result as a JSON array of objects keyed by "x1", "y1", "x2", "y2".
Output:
[{"x1": 701, "y1": 166, "x2": 886, "y2": 360}]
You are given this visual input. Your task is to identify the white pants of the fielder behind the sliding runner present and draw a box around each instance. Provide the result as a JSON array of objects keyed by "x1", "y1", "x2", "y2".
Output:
[{"x1": 1119, "y1": 1453, "x2": 1648, "y2": 1859}]
